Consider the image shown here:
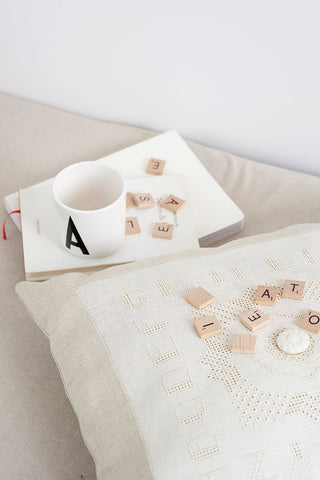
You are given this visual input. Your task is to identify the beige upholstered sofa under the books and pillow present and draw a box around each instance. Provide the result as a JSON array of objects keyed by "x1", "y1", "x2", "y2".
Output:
[{"x1": 0, "y1": 94, "x2": 320, "y2": 480}]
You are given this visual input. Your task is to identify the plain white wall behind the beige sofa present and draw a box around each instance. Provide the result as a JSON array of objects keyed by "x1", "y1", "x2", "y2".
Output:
[{"x1": 0, "y1": 0, "x2": 320, "y2": 175}]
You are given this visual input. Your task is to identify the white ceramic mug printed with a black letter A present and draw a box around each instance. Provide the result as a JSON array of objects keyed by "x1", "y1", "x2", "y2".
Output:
[{"x1": 53, "y1": 162, "x2": 126, "y2": 258}]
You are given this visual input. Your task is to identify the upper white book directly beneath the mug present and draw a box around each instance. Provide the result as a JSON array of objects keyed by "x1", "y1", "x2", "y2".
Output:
[{"x1": 19, "y1": 175, "x2": 199, "y2": 280}]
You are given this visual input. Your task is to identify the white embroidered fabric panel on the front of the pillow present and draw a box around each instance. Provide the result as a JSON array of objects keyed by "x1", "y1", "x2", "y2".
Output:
[{"x1": 77, "y1": 233, "x2": 320, "y2": 480}]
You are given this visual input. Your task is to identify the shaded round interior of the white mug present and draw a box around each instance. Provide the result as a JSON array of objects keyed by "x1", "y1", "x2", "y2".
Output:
[{"x1": 53, "y1": 162, "x2": 124, "y2": 211}]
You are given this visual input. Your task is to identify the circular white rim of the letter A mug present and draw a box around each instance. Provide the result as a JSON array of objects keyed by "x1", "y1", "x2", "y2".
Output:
[{"x1": 52, "y1": 160, "x2": 126, "y2": 215}]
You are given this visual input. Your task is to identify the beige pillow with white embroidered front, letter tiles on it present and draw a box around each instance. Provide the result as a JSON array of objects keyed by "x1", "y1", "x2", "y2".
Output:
[{"x1": 16, "y1": 225, "x2": 320, "y2": 480}]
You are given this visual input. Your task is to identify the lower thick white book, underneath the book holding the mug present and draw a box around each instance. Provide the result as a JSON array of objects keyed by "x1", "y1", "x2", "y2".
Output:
[{"x1": 5, "y1": 130, "x2": 244, "y2": 247}]
